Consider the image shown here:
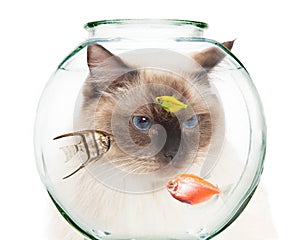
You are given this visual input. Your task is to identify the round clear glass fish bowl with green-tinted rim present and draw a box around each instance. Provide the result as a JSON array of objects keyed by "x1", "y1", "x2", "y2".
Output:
[{"x1": 34, "y1": 20, "x2": 266, "y2": 239}]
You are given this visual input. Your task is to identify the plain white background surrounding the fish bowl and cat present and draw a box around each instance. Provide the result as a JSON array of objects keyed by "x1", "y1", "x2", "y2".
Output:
[{"x1": 0, "y1": 0, "x2": 300, "y2": 240}]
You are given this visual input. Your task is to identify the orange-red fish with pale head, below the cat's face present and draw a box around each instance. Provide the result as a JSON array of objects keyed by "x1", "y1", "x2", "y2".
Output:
[{"x1": 167, "y1": 174, "x2": 221, "y2": 205}]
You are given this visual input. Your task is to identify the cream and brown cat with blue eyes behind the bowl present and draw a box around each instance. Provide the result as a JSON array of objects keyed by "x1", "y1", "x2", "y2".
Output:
[{"x1": 51, "y1": 41, "x2": 278, "y2": 240}]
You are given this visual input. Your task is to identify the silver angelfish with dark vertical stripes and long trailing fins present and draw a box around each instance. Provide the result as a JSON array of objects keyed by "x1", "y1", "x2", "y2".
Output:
[{"x1": 53, "y1": 130, "x2": 113, "y2": 179}]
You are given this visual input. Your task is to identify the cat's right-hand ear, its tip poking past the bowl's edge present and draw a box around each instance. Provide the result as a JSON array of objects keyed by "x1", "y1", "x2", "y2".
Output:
[{"x1": 193, "y1": 40, "x2": 234, "y2": 71}]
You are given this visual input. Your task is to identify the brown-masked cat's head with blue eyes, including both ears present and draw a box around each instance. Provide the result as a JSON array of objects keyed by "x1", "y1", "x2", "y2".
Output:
[{"x1": 78, "y1": 44, "x2": 231, "y2": 176}]
